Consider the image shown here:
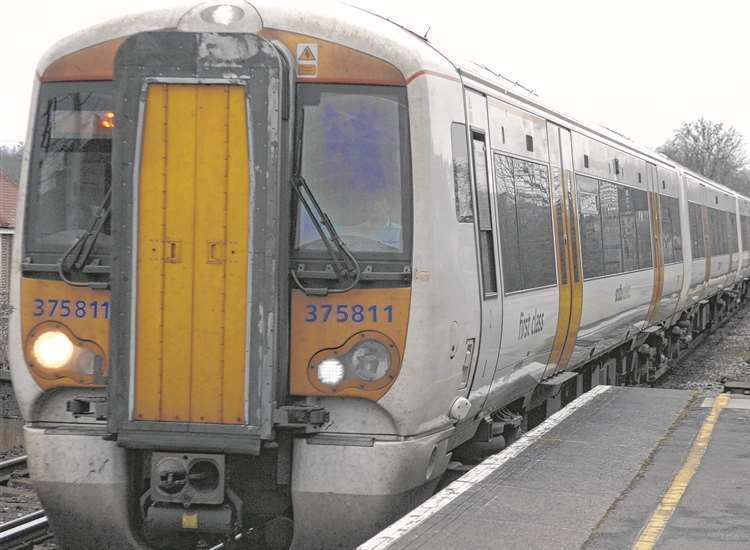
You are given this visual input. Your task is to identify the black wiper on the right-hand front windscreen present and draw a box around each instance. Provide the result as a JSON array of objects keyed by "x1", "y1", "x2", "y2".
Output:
[{"x1": 290, "y1": 175, "x2": 362, "y2": 296}]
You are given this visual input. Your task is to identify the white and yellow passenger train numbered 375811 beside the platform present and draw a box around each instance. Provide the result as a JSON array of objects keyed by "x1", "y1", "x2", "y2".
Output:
[{"x1": 10, "y1": 0, "x2": 750, "y2": 549}]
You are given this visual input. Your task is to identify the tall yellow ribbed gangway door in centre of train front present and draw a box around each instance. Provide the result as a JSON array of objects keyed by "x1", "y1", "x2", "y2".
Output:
[{"x1": 132, "y1": 83, "x2": 250, "y2": 424}]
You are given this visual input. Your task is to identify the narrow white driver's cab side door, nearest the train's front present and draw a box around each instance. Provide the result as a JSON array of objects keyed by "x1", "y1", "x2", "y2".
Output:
[{"x1": 466, "y1": 89, "x2": 503, "y2": 411}]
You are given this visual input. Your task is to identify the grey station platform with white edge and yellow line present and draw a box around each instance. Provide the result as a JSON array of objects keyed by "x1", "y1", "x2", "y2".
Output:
[{"x1": 359, "y1": 386, "x2": 750, "y2": 550}]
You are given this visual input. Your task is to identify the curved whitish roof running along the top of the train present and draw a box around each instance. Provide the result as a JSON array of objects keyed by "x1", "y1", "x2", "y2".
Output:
[{"x1": 37, "y1": 0, "x2": 750, "y2": 205}]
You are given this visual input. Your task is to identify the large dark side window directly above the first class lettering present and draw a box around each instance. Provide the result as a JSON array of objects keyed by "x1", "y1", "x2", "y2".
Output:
[{"x1": 494, "y1": 153, "x2": 557, "y2": 292}]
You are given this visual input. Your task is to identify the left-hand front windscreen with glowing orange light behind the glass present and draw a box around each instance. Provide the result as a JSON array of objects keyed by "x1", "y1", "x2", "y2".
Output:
[{"x1": 25, "y1": 82, "x2": 115, "y2": 263}]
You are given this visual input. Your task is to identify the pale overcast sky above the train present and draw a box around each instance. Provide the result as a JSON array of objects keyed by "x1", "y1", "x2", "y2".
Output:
[{"x1": 0, "y1": 0, "x2": 750, "y2": 158}]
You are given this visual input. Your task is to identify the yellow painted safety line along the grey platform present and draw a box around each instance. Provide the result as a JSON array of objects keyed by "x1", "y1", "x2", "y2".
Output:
[{"x1": 633, "y1": 393, "x2": 730, "y2": 550}]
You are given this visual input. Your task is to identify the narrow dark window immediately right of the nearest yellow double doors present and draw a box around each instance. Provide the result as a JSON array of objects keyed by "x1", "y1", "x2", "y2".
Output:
[{"x1": 577, "y1": 176, "x2": 604, "y2": 279}]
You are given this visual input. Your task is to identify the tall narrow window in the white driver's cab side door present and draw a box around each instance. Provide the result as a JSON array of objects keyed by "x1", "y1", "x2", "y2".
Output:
[{"x1": 471, "y1": 132, "x2": 497, "y2": 297}]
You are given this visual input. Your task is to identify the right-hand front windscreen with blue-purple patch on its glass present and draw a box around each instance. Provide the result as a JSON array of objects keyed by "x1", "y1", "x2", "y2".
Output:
[{"x1": 296, "y1": 84, "x2": 411, "y2": 257}]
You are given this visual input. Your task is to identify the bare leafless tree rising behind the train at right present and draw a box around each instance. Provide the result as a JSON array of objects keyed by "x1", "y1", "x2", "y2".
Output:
[{"x1": 657, "y1": 118, "x2": 750, "y2": 194}]
